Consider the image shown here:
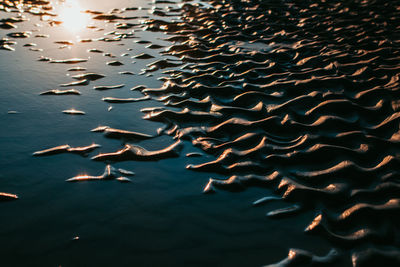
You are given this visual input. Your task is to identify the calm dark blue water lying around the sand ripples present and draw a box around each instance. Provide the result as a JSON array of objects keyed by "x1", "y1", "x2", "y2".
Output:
[{"x1": 0, "y1": 0, "x2": 399, "y2": 266}]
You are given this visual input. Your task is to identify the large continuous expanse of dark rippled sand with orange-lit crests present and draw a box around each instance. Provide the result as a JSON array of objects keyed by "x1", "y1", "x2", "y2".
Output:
[{"x1": 142, "y1": 0, "x2": 400, "y2": 266}]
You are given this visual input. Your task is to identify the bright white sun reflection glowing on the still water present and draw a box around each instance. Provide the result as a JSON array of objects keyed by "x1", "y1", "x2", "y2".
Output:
[{"x1": 58, "y1": 0, "x2": 89, "y2": 33}]
